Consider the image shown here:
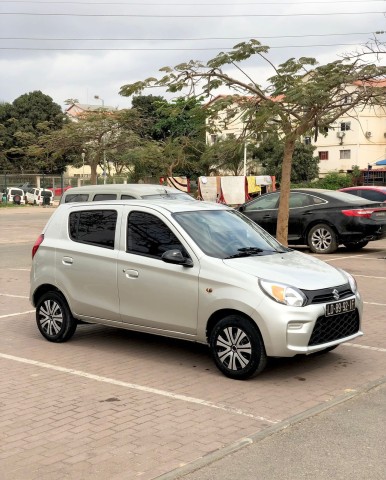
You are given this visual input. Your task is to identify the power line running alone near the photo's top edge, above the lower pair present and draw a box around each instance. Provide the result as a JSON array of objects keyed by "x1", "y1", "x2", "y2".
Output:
[{"x1": 0, "y1": 12, "x2": 385, "y2": 18}]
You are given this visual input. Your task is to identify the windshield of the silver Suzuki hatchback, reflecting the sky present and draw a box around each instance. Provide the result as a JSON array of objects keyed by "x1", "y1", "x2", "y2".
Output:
[{"x1": 173, "y1": 210, "x2": 289, "y2": 259}]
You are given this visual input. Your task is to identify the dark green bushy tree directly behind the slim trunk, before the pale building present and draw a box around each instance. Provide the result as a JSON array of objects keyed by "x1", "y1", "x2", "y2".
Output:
[{"x1": 252, "y1": 135, "x2": 319, "y2": 183}]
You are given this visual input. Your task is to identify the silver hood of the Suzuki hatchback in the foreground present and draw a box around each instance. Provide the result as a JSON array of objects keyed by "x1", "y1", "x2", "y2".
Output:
[{"x1": 223, "y1": 251, "x2": 348, "y2": 290}]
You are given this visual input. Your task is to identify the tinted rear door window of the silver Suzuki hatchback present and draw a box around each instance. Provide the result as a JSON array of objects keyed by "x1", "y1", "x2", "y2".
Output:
[{"x1": 69, "y1": 210, "x2": 117, "y2": 249}]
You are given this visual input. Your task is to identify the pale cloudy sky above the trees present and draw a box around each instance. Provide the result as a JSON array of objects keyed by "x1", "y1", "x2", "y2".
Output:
[{"x1": 0, "y1": 0, "x2": 386, "y2": 108}]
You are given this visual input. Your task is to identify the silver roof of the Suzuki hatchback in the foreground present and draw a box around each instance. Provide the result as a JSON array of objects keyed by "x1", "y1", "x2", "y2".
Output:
[{"x1": 57, "y1": 199, "x2": 228, "y2": 213}]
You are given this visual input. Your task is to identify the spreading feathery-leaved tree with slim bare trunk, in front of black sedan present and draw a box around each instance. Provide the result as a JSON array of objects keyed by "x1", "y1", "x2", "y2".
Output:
[{"x1": 120, "y1": 39, "x2": 386, "y2": 244}]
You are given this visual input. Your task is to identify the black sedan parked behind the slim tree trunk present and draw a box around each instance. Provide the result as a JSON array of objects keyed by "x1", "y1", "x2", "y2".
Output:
[{"x1": 239, "y1": 188, "x2": 386, "y2": 253}]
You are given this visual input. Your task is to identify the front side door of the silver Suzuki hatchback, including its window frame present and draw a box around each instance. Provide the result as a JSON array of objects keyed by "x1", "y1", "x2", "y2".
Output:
[{"x1": 118, "y1": 206, "x2": 200, "y2": 335}]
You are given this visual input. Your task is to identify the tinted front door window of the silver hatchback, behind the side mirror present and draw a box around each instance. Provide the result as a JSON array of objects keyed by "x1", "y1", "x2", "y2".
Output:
[{"x1": 127, "y1": 212, "x2": 187, "y2": 258}]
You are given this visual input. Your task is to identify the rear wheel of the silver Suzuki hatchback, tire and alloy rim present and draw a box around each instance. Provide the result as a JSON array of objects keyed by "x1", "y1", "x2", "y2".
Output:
[{"x1": 36, "y1": 291, "x2": 77, "y2": 343}]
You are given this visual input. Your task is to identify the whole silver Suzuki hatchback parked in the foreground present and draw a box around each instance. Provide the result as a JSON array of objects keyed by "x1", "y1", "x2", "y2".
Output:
[{"x1": 30, "y1": 200, "x2": 362, "y2": 379}]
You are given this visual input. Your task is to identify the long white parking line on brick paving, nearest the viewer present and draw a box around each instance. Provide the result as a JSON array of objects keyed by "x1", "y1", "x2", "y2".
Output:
[{"x1": 0, "y1": 353, "x2": 280, "y2": 424}]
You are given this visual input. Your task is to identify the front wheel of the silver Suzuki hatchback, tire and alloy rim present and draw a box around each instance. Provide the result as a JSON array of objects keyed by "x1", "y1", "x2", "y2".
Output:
[{"x1": 209, "y1": 315, "x2": 267, "y2": 380}]
